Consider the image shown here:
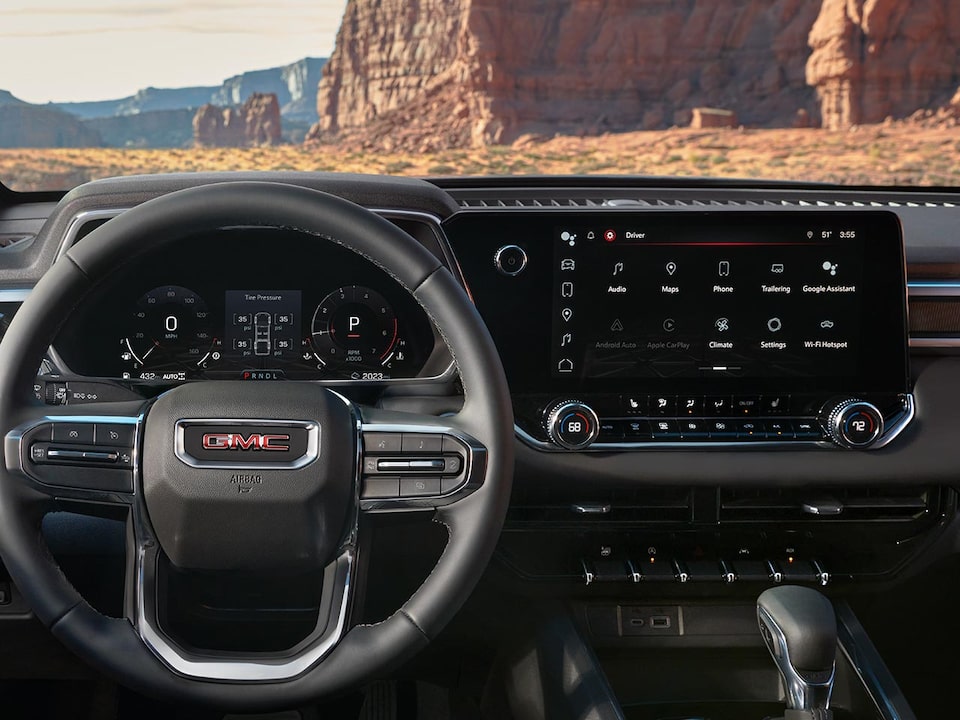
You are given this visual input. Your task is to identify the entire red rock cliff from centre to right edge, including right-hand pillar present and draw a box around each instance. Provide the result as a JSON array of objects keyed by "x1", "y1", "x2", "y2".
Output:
[{"x1": 318, "y1": 0, "x2": 960, "y2": 151}]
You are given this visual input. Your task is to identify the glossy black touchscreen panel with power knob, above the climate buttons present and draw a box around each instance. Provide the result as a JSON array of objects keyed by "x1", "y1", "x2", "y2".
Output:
[{"x1": 448, "y1": 210, "x2": 908, "y2": 393}]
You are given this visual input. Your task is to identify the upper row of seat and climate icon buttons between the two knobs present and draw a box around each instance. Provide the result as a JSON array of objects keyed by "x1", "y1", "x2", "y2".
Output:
[{"x1": 620, "y1": 395, "x2": 791, "y2": 417}]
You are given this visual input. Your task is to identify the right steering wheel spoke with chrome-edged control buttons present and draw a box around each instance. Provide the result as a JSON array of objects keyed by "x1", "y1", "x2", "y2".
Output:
[{"x1": 360, "y1": 408, "x2": 487, "y2": 513}]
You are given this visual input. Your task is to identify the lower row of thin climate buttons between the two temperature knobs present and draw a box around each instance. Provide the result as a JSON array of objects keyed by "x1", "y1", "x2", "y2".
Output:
[{"x1": 597, "y1": 418, "x2": 823, "y2": 443}]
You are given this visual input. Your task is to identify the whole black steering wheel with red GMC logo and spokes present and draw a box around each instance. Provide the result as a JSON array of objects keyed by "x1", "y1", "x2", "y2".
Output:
[{"x1": 0, "y1": 182, "x2": 513, "y2": 711}]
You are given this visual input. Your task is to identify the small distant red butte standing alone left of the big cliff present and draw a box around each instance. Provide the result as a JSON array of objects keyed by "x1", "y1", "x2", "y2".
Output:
[{"x1": 193, "y1": 93, "x2": 281, "y2": 147}]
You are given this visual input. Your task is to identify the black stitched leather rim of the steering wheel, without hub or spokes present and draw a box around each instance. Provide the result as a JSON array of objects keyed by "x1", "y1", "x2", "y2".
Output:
[{"x1": 0, "y1": 182, "x2": 513, "y2": 711}]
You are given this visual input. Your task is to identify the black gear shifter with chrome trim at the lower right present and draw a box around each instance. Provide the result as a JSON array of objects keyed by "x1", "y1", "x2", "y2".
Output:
[{"x1": 757, "y1": 585, "x2": 837, "y2": 720}]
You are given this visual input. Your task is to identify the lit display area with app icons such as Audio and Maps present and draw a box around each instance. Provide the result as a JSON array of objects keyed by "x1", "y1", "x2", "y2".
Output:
[{"x1": 550, "y1": 214, "x2": 876, "y2": 380}]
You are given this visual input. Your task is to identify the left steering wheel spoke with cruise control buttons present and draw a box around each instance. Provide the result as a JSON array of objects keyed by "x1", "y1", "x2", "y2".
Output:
[{"x1": 4, "y1": 402, "x2": 143, "y2": 514}]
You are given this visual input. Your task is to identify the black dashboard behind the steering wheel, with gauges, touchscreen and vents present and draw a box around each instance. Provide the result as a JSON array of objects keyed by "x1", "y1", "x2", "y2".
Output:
[{"x1": 0, "y1": 174, "x2": 960, "y2": 592}]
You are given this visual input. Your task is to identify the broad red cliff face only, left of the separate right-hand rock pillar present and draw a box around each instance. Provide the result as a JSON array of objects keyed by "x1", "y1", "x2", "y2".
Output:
[{"x1": 313, "y1": 0, "x2": 819, "y2": 149}]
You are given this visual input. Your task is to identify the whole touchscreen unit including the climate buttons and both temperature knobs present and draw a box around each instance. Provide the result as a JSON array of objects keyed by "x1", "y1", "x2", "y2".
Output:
[{"x1": 446, "y1": 210, "x2": 913, "y2": 451}]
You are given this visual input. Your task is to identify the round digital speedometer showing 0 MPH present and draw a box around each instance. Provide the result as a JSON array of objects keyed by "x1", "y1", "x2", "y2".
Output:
[{"x1": 121, "y1": 285, "x2": 220, "y2": 379}]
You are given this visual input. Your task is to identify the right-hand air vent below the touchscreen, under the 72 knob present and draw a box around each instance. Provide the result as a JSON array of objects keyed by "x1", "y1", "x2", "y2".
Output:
[{"x1": 720, "y1": 487, "x2": 940, "y2": 523}]
